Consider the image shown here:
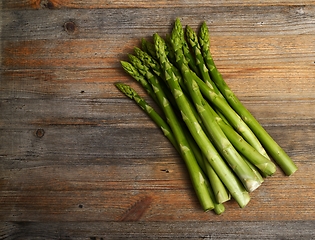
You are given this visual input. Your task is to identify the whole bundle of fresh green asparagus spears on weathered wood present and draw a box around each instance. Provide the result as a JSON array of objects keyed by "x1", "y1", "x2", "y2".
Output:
[{"x1": 116, "y1": 18, "x2": 297, "y2": 214}]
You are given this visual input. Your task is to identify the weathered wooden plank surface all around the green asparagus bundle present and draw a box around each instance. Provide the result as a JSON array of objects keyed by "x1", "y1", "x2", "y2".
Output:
[{"x1": 0, "y1": 0, "x2": 315, "y2": 240}]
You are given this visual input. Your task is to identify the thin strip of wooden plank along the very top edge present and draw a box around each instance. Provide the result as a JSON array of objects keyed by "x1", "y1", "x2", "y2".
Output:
[{"x1": 3, "y1": 0, "x2": 314, "y2": 9}]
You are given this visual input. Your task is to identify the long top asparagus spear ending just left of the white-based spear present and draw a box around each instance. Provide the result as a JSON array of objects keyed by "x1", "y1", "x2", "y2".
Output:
[{"x1": 154, "y1": 33, "x2": 250, "y2": 207}]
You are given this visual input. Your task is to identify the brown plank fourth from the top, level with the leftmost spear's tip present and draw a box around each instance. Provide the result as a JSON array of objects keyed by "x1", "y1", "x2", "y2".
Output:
[{"x1": 0, "y1": 63, "x2": 315, "y2": 101}]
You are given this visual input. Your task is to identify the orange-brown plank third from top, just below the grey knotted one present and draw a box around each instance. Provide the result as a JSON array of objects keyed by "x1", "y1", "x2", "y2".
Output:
[{"x1": 3, "y1": 36, "x2": 315, "y2": 70}]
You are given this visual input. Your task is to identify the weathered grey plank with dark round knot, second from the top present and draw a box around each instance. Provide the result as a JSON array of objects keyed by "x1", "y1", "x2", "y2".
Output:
[{"x1": 2, "y1": 5, "x2": 315, "y2": 40}]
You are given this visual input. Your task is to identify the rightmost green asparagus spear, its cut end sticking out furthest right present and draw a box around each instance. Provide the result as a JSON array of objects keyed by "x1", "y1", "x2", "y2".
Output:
[{"x1": 199, "y1": 23, "x2": 297, "y2": 175}]
